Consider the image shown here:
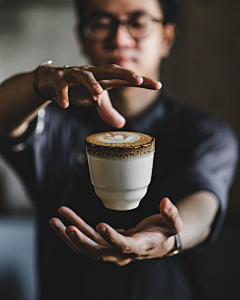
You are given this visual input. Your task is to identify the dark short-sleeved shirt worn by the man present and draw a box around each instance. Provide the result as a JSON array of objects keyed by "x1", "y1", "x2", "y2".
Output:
[{"x1": 1, "y1": 95, "x2": 238, "y2": 300}]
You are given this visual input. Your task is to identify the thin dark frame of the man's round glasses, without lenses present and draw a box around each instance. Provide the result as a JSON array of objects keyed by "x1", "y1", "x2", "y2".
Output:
[{"x1": 82, "y1": 11, "x2": 165, "y2": 42}]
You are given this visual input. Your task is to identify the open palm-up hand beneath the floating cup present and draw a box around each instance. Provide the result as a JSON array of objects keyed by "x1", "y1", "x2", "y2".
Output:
[{"x1": 49, "y1": 198, "x2": 182, "y2": 266}]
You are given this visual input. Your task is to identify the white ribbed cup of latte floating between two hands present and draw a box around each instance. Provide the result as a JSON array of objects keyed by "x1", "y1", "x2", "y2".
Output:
[{"x1": 86, "y1": 131, "x2": 155, "y2": 210}]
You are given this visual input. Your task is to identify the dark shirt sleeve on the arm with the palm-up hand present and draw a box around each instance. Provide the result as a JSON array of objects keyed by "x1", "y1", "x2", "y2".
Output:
[{"x1": 161, "y1": 115, "x2": 239, "y2": 244}]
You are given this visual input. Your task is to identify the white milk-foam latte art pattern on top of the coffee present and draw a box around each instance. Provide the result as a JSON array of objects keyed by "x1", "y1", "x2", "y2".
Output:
[{"x1": 96, "y1": 132, "x2": 141, "y2": 144}]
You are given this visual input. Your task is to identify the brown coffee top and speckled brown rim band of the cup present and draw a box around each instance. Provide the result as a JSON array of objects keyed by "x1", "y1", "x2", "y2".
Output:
[{"x1": 86, "y1": 131, "x2": 155, "y2": 159}]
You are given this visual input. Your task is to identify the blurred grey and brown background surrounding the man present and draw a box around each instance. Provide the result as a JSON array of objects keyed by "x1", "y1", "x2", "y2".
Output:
[{"x1": 0, "y1": 0, "x2": 240, "y2": 300}]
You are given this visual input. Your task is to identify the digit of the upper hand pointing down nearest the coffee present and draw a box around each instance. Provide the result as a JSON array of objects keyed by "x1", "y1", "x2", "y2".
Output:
[{"x1": 97, "y1": 92, "x2": 126, "y2": 128}]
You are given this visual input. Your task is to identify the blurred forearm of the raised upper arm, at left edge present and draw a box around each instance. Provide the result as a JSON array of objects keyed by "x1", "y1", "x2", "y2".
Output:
[{"x1": 0, "y1": 72, "x2": 48, "y2": 137}]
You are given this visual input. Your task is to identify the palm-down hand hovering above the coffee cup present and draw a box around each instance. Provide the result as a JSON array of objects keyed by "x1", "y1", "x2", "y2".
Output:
[{"x1": 38, "y1": 65, "x2": 161, "y2": 128}]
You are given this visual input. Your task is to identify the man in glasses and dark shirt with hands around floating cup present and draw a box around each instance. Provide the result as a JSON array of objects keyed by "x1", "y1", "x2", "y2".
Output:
[{"x1": 0, "y1": 0, "x2": 238, "y2": 300}]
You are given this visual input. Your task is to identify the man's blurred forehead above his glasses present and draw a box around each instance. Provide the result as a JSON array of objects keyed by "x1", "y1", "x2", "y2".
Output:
[{"x1": 86, "y1": 0, "x2": 162, "y2": 17}]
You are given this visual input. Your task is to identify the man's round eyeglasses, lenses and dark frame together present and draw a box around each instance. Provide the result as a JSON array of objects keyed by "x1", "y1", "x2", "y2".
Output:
[{"x1": 83, "y1": 13, "x2": 163, "y2": 41}]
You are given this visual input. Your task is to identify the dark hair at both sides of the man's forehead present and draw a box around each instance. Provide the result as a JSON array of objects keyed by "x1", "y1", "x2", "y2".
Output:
[{"x1": 74, "y1": 0, "x2": 176, "y2": 24}]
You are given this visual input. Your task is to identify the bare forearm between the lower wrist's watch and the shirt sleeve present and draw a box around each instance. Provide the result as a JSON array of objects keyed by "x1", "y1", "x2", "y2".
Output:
[{"x1": 176, "y1": 192, "x2": 219, "y2": 250}]
